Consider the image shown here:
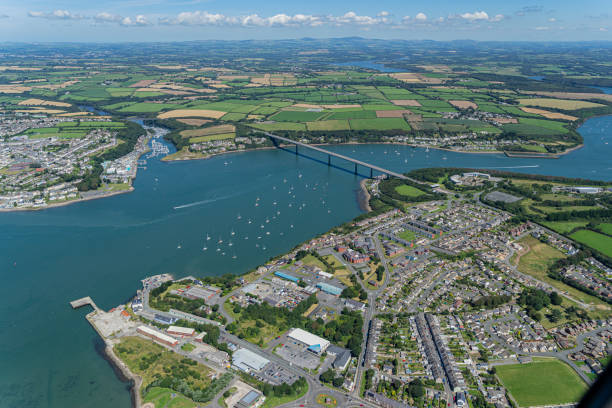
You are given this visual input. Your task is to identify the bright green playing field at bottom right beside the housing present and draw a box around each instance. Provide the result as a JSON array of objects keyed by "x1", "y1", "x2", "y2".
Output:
[{"x1": 496, "y1": 359, "x2": 587, "y2": 407}]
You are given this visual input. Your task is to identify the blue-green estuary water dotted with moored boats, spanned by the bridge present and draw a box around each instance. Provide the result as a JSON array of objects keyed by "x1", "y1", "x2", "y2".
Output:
[{"x1": 0, "y1": 116, "x2": 612, "y2": 408}]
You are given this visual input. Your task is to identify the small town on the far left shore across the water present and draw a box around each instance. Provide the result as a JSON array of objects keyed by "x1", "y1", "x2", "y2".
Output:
[{"x1": 0, "y1": 112, "x2": 155, "y2": 211}]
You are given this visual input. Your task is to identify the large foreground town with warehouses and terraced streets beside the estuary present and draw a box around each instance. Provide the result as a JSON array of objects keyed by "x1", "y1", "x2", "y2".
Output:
[{"x1": 73, "y1": 173, "x2": 612, "y2": 408}]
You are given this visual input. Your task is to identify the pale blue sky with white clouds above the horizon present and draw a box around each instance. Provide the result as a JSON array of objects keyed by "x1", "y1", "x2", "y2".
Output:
[{"x1": 0, "y1": 0, "x2": 612, "y2": 42}]
